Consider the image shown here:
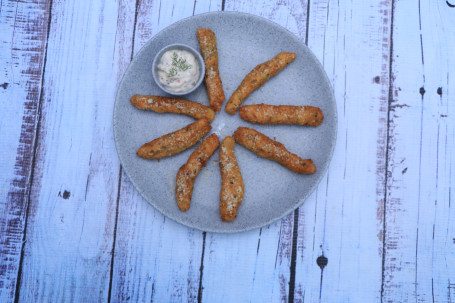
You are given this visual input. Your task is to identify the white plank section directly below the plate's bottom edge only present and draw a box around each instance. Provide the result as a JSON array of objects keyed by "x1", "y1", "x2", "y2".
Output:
[{"x1": 202, "y1": 220, "x2": 293, "y2": 302}]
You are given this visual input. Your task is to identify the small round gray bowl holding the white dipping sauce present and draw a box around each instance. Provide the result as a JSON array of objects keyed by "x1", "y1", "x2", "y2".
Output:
[{"x1": 153, "y1": 43, "x2": 205, "y2": 96}]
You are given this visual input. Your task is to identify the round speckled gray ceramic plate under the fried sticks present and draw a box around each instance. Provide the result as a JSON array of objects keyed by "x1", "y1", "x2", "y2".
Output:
[{"x1": 114, "y1": 12, "x2": 337, "y2": 232}]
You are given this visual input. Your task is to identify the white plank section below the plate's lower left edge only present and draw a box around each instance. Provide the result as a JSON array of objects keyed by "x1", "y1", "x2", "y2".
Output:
[{"x1": 111, "y1": 174, "x2": 203, "y2": 302}]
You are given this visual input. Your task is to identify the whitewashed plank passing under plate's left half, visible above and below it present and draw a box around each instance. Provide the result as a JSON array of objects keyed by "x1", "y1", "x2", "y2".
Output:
[{"x1": 111, "y1": 1, "x2": 221, "y2": 302}]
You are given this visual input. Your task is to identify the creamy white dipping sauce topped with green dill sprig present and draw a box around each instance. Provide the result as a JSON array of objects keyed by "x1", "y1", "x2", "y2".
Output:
[{"x1": 158, "y1": 49, "x2": 199, "y2": 92}]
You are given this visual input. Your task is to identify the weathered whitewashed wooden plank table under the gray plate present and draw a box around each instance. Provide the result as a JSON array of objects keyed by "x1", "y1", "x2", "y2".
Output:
[{"x1": 0, "y1": 0, "x2": 455, "y2": 302}]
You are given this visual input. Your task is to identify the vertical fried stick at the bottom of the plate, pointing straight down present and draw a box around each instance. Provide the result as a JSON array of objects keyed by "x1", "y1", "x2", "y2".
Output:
[{"x1": 220, "y1": 136, "x2": 245, "y2": 221}]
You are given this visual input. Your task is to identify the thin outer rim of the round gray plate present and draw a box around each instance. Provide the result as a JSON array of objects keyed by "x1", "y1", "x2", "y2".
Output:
[{"x1": 112, "y1": 11, "x2": 338, "y2": 234}]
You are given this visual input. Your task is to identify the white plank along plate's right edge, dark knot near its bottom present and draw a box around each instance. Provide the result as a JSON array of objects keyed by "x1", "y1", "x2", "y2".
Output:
[{"x1": 295, "y1": 0, "x2": 391, "y2": 302}]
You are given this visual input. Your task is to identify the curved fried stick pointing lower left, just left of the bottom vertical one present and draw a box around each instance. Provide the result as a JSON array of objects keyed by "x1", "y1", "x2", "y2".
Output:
[{"x1": 175, "y1": 134, "x2": 220, "y2": 211}]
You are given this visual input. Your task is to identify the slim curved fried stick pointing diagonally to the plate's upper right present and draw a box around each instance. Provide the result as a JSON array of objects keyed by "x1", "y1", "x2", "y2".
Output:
[{"x1": 225, "y1": 52, "x2": 297, "y2": 115}]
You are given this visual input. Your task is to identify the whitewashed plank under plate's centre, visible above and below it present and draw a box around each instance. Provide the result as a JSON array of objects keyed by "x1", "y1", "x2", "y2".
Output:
[{"x1": 202, "y1": 0, "x2": 307, "y2": 302}]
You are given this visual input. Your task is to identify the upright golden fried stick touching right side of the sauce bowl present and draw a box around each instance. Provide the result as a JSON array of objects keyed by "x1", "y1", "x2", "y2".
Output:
[{"x1": 197, "y1": 28, "x2": 225, "y2": 112}]
